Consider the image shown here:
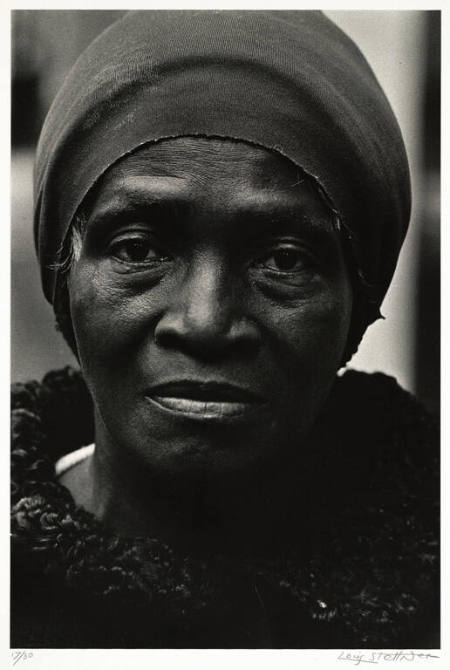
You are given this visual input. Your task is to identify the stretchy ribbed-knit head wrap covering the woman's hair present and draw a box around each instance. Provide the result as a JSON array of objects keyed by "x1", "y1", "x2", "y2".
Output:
[{"x1": 34, "y1": 11, "x2": 410, "y2": 346}]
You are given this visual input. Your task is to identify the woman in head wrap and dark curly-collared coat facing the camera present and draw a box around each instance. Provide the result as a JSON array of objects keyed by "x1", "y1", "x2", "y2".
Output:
[{"x1": 12, "y1": 11, "x2": 438, "y2": 648}]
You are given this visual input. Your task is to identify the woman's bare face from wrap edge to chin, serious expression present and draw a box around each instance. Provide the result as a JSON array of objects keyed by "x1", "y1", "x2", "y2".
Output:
[{"x1": 69, "y1": 138, "x2": 352, "y2": 475}]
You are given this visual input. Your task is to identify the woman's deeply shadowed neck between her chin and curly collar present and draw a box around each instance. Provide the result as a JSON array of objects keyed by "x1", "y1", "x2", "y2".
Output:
[{"x1": 61, "y1": 430, "x2": 314, "y2": 554}]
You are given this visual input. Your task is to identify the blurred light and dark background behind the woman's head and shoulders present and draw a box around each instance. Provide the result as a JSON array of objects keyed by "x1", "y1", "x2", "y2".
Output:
[{"x1": 11, "y1": 10, "x2": 441, "y2": 410}]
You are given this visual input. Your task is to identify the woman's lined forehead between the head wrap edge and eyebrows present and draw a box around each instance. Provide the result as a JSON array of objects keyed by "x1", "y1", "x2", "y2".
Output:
[{"x1": 87, "y1": 137, "x2": 332, "y2": 232}]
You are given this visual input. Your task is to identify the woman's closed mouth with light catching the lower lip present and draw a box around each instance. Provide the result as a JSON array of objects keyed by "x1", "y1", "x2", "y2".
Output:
[{"x1": 145, "y1": 380, "x2": 266, "y2": 420}]
